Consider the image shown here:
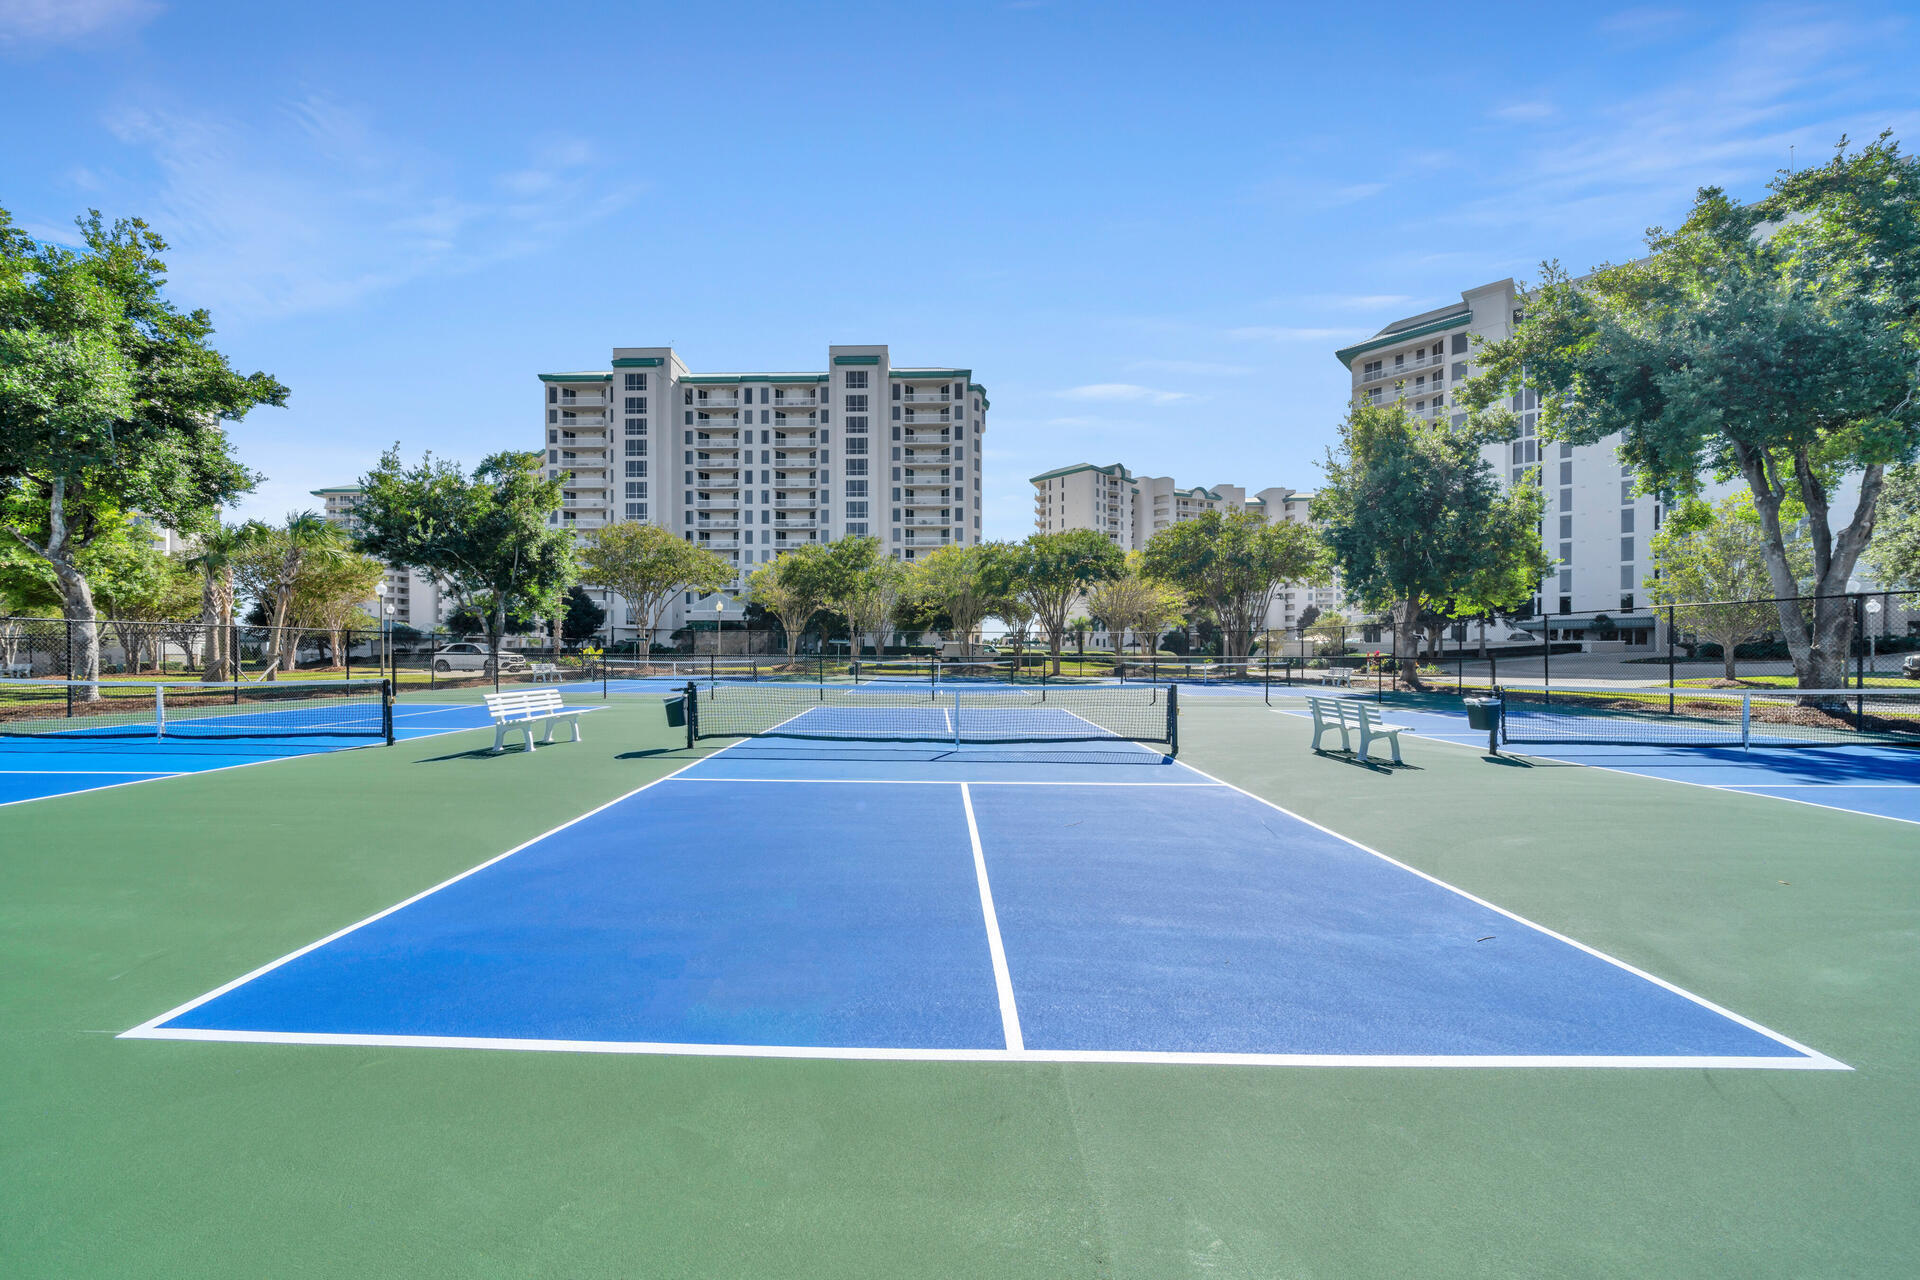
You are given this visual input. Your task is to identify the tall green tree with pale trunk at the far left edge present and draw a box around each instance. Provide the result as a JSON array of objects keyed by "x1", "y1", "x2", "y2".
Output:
[{"x1": 0, "y1": 209, "x2": 286, "y2": 679}]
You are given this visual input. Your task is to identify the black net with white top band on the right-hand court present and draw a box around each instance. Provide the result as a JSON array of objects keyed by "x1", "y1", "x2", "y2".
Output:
[{"x1": 1500, "y1": 685, "x2": 1920, "y2": 747}]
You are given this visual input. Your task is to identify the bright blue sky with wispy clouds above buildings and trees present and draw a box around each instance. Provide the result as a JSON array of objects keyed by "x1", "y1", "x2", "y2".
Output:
[{"x1": 0, "y1": 0, "x2": 1920, "y2": 537}]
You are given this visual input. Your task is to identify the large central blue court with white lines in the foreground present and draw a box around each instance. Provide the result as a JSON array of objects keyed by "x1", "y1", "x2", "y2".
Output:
[{"x1": 125, "y1": 721, "x2": 1841, "y2": 1069}]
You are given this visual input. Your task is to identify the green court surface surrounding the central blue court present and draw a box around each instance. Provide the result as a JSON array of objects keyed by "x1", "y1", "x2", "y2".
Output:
[{"x1": 0, "y1": 699, "x2": 1920, "y2": 1278}]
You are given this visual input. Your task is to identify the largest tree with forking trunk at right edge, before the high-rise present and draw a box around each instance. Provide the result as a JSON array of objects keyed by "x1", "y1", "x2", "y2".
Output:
[{"x1": 1465, "y1": 134, "x2": 1920, "y2": 689}]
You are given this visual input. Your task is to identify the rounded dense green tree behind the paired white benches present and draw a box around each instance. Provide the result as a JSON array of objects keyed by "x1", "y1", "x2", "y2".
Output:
[{"x1": 1313, "y1": 403, "x2": 1548, "y2": 687}]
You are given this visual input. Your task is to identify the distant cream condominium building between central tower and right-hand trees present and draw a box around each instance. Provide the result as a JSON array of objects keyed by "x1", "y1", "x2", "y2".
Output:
[{"x1": 1033, "y1": 462, "x2": 1340, "y2": 628}]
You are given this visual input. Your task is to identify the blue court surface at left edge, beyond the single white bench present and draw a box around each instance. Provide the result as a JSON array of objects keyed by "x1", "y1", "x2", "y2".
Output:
[{"x1": 0, "y1": 702, "x2": 506, "y2": 806}]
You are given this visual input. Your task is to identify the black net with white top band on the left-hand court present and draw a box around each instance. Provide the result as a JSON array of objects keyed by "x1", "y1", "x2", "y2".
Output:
[{"x1": 0, "y1": 679, "x2": 392, "y2": 741}]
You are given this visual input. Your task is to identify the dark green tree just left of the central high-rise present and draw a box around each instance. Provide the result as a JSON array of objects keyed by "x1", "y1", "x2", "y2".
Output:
[{"x1": 353, "y1": 445, "x2": 578, "y2": 685}]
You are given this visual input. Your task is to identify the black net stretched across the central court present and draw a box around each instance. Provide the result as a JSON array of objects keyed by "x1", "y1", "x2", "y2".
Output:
[{"x1": 685, "y1": 683, "x2": 1179, "y2": 754}]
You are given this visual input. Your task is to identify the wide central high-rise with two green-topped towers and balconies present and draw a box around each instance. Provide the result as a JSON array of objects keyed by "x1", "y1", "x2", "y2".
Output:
[{"x1": 540, "y1": 345, "x2": 987, "y2": 626}]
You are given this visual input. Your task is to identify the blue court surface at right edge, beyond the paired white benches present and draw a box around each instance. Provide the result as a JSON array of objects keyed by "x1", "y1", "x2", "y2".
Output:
[{"x1": 1274, "y1": 689, "x2": 1920, "y2": 823}]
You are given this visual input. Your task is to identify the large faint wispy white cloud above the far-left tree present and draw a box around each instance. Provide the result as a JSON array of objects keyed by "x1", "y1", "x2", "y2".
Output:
[{"x1": 99, "y1": 98, "x2": 634, "y2": 317}]
